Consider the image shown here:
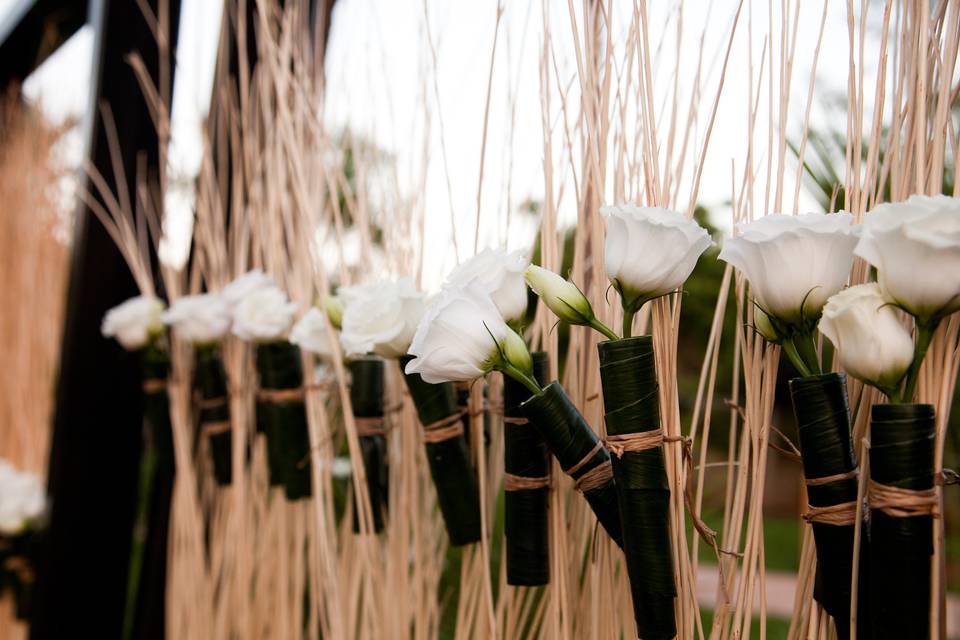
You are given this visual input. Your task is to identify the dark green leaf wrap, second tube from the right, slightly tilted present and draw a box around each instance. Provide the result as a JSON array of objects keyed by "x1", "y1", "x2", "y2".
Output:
[{"x1": 790, "y1": 373, "x2": 869, "y2": 640}]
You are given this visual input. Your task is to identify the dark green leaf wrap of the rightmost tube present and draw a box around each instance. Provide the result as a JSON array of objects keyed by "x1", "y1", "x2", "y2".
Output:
[{"x1": 869, "y1": 404, "x2": 935, "y2": 639}]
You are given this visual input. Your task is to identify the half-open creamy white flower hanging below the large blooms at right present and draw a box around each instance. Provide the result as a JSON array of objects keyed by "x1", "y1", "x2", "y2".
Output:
[{"x1": 820, "y1": 282, "x2": 913, "y2": 391}]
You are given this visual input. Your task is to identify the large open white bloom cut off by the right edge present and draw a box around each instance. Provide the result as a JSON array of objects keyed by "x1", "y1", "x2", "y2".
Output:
[{"x1": 854, "y1": 196, "x2": 960, "y2": 321}]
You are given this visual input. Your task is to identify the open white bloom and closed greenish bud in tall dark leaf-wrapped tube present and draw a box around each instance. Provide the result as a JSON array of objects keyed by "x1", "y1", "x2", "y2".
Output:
[{"x1": 528, "y1": 206, "x2": 712, "y2": 638}]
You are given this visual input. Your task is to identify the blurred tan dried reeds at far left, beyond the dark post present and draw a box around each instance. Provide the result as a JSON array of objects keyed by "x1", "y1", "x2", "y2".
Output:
[{"x1": 0, "y1": 94, "x2": 70, "y2": 638}]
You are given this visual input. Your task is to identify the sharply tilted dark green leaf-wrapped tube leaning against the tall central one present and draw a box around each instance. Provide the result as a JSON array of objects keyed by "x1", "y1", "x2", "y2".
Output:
[{"x1": 520, "y1": 382, "x2": 623, "y2": 547}]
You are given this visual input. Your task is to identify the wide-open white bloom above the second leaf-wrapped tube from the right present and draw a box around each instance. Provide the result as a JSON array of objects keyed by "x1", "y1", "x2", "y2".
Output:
[{"x1": 719, "y1": 212, "x2": 857, "y2": 326}]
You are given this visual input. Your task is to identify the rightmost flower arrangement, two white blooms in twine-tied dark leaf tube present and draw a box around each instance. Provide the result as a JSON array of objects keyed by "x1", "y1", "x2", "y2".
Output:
[{"x1": 819, "y1": 196, "x2": 960, "y2": 637}]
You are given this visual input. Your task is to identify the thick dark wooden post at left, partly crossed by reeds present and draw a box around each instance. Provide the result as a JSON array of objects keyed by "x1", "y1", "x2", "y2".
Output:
[{"x1": 31, "y1": 0, "x2": 180, "y2": 639}]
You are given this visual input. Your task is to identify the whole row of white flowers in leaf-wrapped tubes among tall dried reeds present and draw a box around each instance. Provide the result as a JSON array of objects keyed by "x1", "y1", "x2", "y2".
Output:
[{"x1": 65, "y1": 2, "x2": 960, "y2": 639}]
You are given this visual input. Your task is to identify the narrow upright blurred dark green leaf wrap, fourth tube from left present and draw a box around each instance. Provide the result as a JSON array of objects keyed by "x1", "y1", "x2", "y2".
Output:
[{"x1": 347, "y1": 355, "x2": 389, "y2": 533}]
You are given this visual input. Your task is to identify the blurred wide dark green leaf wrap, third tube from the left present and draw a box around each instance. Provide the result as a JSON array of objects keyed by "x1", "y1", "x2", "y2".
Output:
[{"x1": 257, "y1": 342, "x2": 313, "y2": 500}]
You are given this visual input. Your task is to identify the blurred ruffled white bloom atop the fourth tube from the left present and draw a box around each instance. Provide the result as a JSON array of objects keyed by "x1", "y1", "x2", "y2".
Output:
[{"x1": 337, "y1": 278, "x2": 425, "y2": 358}]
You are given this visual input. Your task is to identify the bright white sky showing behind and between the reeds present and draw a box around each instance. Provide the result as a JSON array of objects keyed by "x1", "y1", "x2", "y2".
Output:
[{"x1": 0, "y1": 0, "x2": 900, "y2": 287}]
